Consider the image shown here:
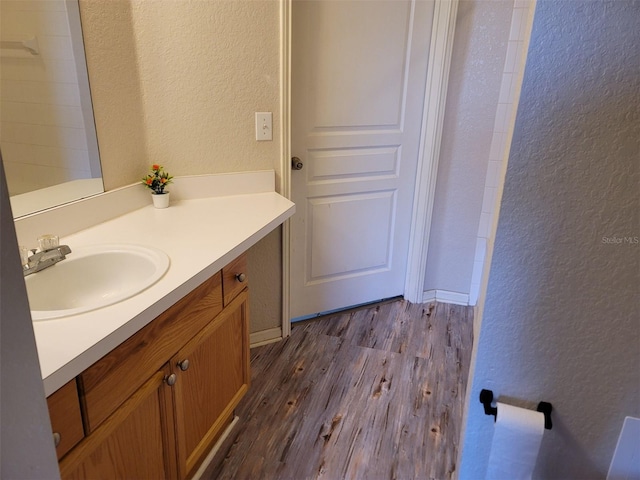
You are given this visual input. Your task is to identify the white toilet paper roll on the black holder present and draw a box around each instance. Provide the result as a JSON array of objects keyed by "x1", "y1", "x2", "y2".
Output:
[{"x1": 486, "y1": 402, "x2": 544, "y2": 480}]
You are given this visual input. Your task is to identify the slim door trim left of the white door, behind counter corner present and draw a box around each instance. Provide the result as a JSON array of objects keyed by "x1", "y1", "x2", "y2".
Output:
[{"x1": 278, "y1": 0, "x2": 292, "y2": 338}]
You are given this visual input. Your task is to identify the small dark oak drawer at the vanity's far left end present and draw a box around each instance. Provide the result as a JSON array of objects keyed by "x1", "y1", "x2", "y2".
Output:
[{"x1": 47, "y1": 378, "x2": 84, "y2": 459}]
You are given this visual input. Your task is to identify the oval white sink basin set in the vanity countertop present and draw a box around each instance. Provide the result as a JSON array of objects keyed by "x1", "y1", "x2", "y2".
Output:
[{"x1": 25, "y1": 244, "x2": 169, "y2": 320}]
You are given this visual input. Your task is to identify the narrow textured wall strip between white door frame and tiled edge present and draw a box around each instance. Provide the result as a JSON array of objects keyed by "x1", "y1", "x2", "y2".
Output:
[{"x1": 424, "y1": 0, "x2": 513, "y2": 294}]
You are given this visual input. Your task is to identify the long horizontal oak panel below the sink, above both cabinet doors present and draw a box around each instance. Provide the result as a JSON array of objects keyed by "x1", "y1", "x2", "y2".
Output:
[{"x1": 78, "y1": 272, "x2": 222, "y2": 433}]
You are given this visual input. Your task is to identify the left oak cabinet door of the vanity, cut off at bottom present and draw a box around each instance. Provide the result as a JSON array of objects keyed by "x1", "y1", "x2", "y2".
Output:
[{"x1": 60, "y1": 365, "x2": 177, "y2": 479}]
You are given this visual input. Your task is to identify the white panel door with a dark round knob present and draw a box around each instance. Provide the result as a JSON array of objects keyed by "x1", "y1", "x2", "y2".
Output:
[{"x1": 291, "y1": 0, "x2": 433, "y2": 318}]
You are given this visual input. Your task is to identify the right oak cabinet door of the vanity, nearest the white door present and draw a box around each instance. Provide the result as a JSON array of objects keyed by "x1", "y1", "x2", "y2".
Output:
[{"x1": 171, "y1": 290, "x2": 249, "y2": 477}]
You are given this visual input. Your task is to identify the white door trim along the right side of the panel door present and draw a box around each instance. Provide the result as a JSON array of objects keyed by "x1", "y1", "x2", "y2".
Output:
[{"x1": 404, "y1": 0, "x2": 458, "y2": 303}]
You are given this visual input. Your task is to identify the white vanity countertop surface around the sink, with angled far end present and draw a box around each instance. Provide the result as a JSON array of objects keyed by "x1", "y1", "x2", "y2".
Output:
[{"x1": 33, "y1": 174, "x2": 295, "y2": 395}]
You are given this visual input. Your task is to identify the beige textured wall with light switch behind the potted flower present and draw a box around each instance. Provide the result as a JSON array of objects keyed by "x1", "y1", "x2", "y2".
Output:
[{"x1": 80, "y1": 0, "x2": 282, "y2": 331}]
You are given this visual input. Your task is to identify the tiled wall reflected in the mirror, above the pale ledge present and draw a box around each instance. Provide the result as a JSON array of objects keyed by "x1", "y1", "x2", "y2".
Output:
[{"x1": 0, "y1": 0, "x2": 92, "y2": 195}]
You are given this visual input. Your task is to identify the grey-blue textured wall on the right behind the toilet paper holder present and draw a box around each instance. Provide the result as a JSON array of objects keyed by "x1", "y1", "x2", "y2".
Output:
[{"x1": 461, "y1": 0, "x2": 640, "y2": 479}]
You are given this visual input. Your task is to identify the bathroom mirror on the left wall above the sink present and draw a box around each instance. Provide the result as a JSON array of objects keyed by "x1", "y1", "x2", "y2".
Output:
[{"x1": 0, "y1": 0, "x2": 104, "y2": 218}]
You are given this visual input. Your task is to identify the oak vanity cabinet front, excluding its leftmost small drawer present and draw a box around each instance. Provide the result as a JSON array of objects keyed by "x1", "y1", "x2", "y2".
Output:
[{"x1": 50, "y1": 253, "x2": 250, "y2": 479}]
